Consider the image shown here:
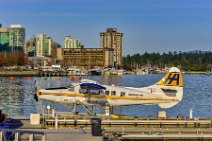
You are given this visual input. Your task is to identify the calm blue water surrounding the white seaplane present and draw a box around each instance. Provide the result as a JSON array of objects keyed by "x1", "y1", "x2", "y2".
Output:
[{"x1": 0, "y1": 74, "x2": 212, "y2": 117}]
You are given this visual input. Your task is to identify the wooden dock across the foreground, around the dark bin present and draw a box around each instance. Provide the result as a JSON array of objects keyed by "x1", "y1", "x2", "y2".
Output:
[{"x1": 0, "y1": 115, "x2": 212, "y2": 141}]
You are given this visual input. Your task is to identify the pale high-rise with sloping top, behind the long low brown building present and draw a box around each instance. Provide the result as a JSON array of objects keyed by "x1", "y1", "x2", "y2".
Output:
[{"x1": 64, "y1": 36, "x2": 83, "y2": 48}]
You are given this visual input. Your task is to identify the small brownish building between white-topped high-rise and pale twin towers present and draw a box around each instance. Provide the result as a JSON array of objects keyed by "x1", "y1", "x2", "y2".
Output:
[{"x1": 25, "y1": 36, "x2": 36, "y2": 57}]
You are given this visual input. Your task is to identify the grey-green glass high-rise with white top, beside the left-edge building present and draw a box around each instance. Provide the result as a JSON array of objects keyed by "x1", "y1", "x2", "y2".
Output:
[{"x1": 9, "y1": 24, "x2": 25, "y2": 51}]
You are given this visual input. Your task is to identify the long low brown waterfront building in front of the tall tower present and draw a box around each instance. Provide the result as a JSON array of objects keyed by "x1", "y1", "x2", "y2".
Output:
[{"x1": 62, "y1": 48, "x2": 113, "y2": 68}]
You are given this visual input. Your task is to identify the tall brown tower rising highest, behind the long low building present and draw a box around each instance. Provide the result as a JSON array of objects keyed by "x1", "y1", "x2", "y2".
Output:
[{"x1": 100, "y1": 28, "x2": 123, "y2": 67}]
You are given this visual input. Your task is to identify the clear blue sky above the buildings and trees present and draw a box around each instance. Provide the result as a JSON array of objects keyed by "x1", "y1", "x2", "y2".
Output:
[{"x1": 0, "y1": 0, "x2": 212, "y2": 55}]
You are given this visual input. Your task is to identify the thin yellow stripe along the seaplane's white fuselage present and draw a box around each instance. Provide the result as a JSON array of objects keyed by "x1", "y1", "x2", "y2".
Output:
[{"x1": 39, "y1": 91, "x2": 178, "y2": 101}]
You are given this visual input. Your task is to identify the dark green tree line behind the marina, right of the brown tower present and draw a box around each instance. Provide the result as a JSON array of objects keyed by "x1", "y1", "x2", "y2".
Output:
[{"x1": 123, "y1": 52, "x2": 212, "y2": 71}]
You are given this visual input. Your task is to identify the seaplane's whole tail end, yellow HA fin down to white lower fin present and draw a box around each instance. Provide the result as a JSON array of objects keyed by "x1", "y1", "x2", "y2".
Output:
[{"x1": 156, "y1": 67, "x2": 183, "y2": 108}]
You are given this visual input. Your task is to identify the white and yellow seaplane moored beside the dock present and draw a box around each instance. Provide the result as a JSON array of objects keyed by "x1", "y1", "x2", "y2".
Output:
[{"x1": 35, "y1": 67, "x2": 183, "y2": 115}]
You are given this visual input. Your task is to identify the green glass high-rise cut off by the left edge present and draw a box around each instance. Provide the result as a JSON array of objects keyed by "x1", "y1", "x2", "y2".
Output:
[{"x1": 0, "y1": 28, "x2": 11, "y2": 51}]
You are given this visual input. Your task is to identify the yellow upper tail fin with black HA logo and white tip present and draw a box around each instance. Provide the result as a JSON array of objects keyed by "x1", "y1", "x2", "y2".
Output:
[{"x1": 156, "y1": 67, "x2": 183, "y2": 87}]
